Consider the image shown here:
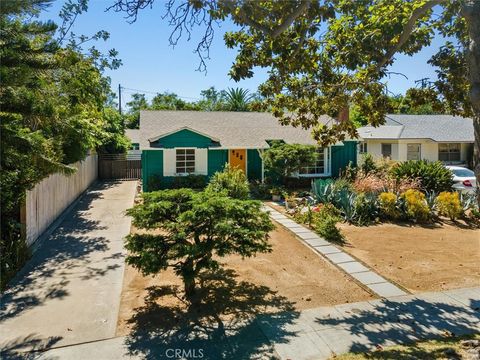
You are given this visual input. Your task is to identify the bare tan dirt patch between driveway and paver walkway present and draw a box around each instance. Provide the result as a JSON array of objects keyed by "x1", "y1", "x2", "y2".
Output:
[{"x1": 117, "y1": 226, "x2": 373, "y2": 335}]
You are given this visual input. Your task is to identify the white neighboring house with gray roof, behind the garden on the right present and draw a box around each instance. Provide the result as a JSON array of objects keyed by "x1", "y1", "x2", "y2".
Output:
[{"x1": 358, "y1": 115, "x2": 474, "y2": 164}]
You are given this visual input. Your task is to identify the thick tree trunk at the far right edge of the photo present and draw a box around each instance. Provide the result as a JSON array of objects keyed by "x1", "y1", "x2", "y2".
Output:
[{"x1": 462, "y1": 0, "x2": 480, "y2": 205}]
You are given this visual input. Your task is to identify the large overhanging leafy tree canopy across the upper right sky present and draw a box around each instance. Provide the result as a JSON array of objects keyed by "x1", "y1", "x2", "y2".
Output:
[{"x1": 111, "y1": 0, "x2": 480, "y2": 202}]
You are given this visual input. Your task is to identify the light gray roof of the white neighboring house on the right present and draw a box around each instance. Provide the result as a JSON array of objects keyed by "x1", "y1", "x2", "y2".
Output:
[{"x1": 358, "y1": 114, "x2": 474, "y2": 142}]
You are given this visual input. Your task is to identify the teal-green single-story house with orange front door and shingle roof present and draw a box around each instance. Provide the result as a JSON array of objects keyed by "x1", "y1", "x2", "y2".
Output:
[{"x1": 127, "y1": 110, "x2": 357, "y2": 191}]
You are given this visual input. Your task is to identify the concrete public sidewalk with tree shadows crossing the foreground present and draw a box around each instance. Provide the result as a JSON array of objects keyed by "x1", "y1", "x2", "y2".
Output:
[{"x1": 32, "y1": 288, "x2": 480, "y2": 360}]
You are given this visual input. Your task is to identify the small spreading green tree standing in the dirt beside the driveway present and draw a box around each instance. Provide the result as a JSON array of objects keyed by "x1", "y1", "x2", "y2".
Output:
[{"x1": 125, "y1": 189, "x2": 273, "y2": 301}]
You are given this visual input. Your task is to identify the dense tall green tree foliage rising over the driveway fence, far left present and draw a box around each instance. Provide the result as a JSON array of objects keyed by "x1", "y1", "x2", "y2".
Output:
[{"x1": 0, "y1": 0, "x2": 127, "y2": 286}]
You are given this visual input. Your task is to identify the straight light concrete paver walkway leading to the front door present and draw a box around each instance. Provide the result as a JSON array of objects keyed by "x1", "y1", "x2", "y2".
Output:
[{"x1": 264, "y1": 202, "x2": 407, "y2": 298}]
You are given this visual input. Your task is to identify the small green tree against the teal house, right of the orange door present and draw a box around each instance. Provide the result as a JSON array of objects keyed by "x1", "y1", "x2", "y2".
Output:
[{"x1": 263, "y1": 141, "x2": 317, "y2": 181}]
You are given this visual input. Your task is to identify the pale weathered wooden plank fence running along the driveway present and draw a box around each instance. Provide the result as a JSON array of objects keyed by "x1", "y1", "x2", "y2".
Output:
[{"x1": 22, "y1": 154, "x2": 98, "y2": 246}]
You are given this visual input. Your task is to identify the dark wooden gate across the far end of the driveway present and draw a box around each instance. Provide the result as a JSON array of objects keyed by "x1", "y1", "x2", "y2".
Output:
[{"x1": 98, "y1": 154, "x2": 142, "y2": 180}]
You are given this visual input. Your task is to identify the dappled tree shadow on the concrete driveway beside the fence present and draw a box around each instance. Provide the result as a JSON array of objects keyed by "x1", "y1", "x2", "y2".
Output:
[{"x1": 0, "y1": 183, "x2": 121, "y2": 325}]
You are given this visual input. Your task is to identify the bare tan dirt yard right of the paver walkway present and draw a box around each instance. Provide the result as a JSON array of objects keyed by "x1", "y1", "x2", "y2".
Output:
[{"x1": 338, "y1": 223, "x2": 480, "y2": 293}]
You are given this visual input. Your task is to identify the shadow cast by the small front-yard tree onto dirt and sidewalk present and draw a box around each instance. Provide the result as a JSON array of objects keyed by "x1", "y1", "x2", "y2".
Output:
[{"x1": 126, "y1": 270, "x2": 299, "y2": 359}]
